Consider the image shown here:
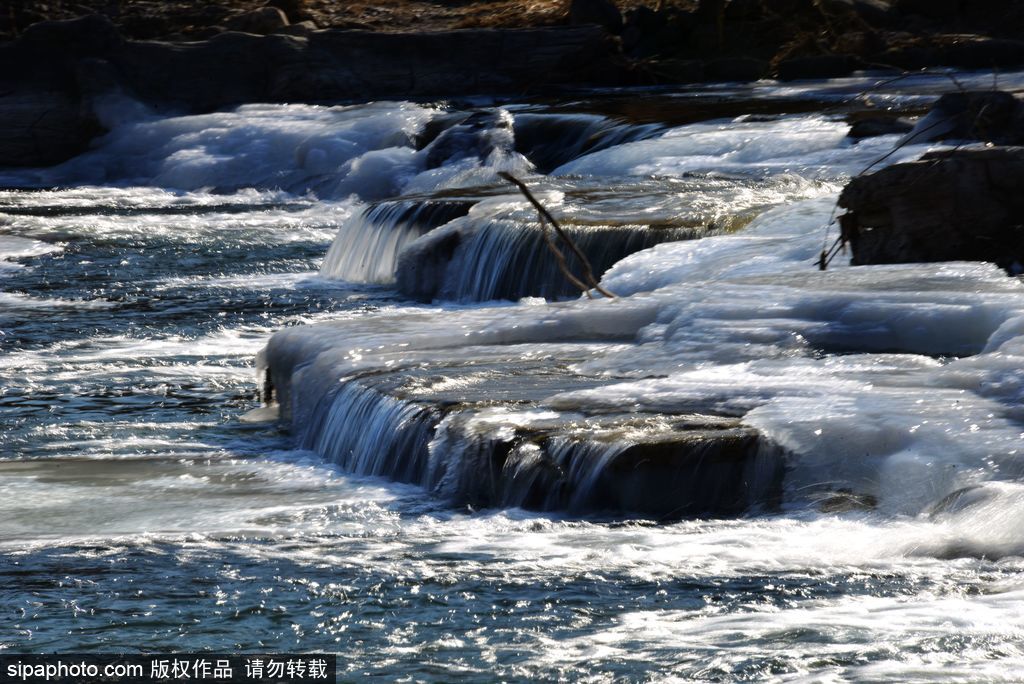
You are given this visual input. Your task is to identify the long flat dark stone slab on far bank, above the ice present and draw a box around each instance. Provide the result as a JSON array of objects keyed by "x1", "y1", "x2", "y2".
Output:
[{"x1": 101, "y1": 26, "x2": 628, "y2": 112}]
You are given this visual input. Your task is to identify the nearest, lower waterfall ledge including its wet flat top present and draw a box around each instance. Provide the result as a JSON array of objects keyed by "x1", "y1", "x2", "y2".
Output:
[{"x1": 260, "y1": 304, "x2": 784, "y2": 519}]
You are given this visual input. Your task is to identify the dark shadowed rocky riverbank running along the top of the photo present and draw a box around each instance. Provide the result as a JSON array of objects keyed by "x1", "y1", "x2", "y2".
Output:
[{"x1": 6, "y1": 0, "x2": 1024, "y2": 166}]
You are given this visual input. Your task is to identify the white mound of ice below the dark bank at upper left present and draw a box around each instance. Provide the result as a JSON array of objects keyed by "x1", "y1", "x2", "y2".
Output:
[{"x1": 8, "y1": 102, "x2": 436, "y2": 199}]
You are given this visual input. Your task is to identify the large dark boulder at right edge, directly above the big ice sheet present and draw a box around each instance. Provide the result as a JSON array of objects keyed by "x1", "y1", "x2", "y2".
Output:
[{"x1": 839, "y1": 146, "x2": 1024, "y2": 273}]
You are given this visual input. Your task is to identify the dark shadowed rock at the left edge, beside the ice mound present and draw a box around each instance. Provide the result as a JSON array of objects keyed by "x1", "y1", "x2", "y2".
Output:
[{"x1": 0, "y1": 92, "x2": 99, "y2": 166}]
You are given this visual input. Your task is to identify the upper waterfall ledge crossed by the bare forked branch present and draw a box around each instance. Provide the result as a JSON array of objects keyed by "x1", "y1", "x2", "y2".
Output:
[{"x1": 321, "y1": 175, "x2": 821, "y2": 302}]
